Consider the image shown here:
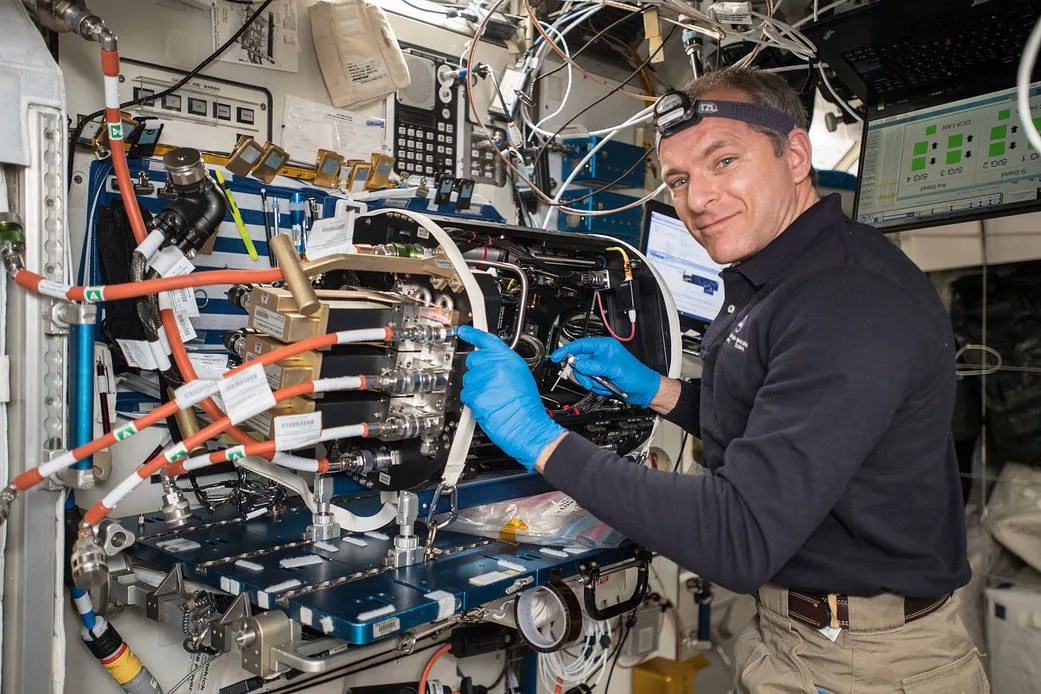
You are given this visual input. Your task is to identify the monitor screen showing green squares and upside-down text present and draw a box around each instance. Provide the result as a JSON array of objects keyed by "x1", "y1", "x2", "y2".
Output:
[{"x1": 854, "y1": 82, "x2": 1041, "y2": 232}]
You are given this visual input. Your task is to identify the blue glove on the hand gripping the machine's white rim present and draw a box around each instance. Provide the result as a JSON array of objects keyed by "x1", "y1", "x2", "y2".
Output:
[{"x1": 458, "y1": 326, "x2": 565, "y2": 470}]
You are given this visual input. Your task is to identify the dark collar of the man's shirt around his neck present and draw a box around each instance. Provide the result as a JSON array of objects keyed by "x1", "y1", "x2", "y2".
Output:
[{"x1": 731, "y1": 192, "x2": 846, "y2": 289}]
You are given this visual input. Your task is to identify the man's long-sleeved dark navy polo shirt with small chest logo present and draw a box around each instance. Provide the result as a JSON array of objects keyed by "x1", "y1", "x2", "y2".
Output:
[{"x1": 544, "y1": 196, "x2": 969, "y2": 597}]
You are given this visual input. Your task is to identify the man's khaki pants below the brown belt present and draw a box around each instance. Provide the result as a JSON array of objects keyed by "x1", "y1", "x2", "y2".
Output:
[{"x1": 734, "y1": 586, "x2": 990, "y2": 694}]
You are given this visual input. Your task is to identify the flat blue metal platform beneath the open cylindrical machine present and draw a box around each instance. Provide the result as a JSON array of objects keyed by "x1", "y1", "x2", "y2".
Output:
[{"x1": 124, "y1": 497, "x2": 633, "y2": 644}]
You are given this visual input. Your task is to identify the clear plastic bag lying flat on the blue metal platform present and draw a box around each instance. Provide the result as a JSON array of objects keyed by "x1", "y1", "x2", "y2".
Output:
[{"x1": 442, "y1": 491, "x2": 625, "y2": 548}]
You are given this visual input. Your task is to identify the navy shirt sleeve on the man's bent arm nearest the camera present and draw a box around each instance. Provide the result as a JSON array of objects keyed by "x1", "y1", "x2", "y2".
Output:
[{"x1": 543, "y1": 268, "x2": 941, "y2": 592}]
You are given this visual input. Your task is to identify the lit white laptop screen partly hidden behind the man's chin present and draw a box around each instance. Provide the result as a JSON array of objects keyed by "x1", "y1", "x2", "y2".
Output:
[{"x1": 643, "y1": 201, "x2": 726, "y2": 333}]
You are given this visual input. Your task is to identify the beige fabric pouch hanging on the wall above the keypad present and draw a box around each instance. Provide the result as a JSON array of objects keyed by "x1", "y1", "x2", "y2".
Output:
[{"x1": 307, "y1": 0, "x2": 409, "y2": 107}]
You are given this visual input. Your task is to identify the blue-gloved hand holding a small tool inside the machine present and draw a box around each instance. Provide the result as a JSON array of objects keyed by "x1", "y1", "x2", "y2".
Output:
[{"x1": 550, "y1": 337, "x2": 661, "y2": 407}]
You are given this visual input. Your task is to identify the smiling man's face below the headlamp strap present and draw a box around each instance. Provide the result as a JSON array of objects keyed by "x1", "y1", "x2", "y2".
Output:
[{"x1": 658, "y1": 88, "x2": 808, "y2": 264}]
